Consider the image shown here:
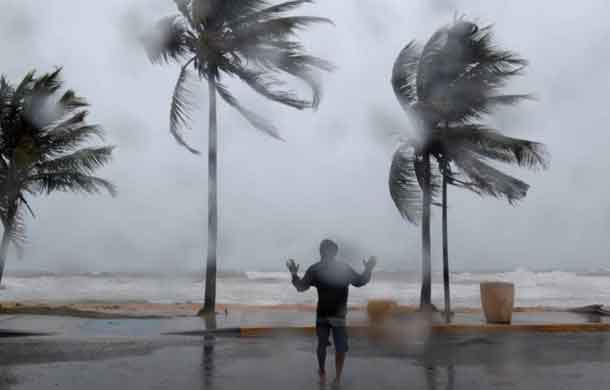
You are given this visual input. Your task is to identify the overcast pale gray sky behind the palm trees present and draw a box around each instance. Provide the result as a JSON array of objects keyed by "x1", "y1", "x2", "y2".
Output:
[{"x1": 0, "y1": 0, "x2": 610, "y2": 271}]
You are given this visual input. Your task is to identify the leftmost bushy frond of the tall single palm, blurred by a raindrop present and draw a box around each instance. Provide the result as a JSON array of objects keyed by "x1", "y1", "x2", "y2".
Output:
[{"x1": 142, "y1": 16, "x2": 189, "y2": 64}]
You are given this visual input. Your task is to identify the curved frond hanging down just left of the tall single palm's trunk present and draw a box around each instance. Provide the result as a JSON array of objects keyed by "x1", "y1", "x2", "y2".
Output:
[{"x1": 169, "y1": 61, "x2": 199, "y2": 154}]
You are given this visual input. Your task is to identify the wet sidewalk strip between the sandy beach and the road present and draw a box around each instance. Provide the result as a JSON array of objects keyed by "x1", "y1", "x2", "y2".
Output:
[{"x1": 0, "y1": 309, "x2": 610, "y2": 337}]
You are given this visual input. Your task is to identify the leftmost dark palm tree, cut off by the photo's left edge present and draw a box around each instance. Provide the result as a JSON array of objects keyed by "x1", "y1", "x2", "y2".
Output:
[{"x1": 0, "y1": 69, "x2": 116, "y2": 281}]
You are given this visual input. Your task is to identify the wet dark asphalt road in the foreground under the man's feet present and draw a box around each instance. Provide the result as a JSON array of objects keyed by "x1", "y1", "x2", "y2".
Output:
[{"x1": 0, "y1": 333, "x2": 610, "y2": 390}]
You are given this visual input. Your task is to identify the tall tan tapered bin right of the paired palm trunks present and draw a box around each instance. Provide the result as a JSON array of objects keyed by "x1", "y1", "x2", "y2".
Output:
[{"x1": 481, "y1": 282, "x2": 515, "y2": 324}]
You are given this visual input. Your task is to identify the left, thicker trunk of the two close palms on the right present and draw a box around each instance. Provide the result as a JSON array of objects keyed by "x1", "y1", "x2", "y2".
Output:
[{"x1": 420, "y1": 153, "x2": 432, "y2": 309}]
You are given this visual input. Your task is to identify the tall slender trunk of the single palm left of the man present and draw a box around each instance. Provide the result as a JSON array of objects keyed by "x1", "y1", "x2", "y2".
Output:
[{"x1": 199, "y1": 75, "x2": 218, "y2": 314}]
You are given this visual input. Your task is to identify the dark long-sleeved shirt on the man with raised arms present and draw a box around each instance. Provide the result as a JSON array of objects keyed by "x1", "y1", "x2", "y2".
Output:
[{"x1": 292, "y1": 260, "x2": 371, "y2": 318}]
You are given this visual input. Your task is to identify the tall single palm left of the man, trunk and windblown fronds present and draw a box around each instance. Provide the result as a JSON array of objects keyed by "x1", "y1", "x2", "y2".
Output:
[{"x1": 144, "y1": 0, "x2": 333, "y2": 314}]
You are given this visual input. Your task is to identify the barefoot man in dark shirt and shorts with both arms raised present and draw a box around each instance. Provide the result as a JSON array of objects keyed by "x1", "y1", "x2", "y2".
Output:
[{"x1": 286, "y1": 240, "x2": 377, "y2": 384}]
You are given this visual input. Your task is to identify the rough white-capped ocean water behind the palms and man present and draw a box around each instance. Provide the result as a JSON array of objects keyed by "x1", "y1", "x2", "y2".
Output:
[{"x1": 0, "y1": 269, "x2": 610, "y2": 308}]
